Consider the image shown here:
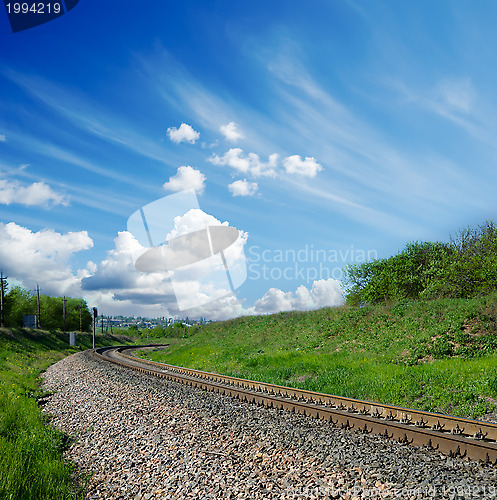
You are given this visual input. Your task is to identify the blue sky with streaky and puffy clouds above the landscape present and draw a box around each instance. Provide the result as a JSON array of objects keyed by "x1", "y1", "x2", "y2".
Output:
[{"x1": 0, "y1": 0, "x2": 497, "y2": 318}]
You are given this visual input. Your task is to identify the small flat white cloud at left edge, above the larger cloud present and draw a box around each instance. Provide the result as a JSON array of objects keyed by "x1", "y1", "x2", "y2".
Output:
[{"x1": 0, "y1": 179, "x2": 69, "y2": 207}]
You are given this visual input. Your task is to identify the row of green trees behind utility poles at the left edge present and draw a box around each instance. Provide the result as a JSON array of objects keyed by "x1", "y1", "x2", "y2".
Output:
[{"x1": 3, "y1": 286, "x2": 92, "y2": 332}]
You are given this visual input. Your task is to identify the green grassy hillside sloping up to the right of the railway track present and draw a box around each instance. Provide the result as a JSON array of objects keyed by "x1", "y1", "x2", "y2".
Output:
[{"x1": 147, "y1": 294, "x2": 497, "y2": 417}]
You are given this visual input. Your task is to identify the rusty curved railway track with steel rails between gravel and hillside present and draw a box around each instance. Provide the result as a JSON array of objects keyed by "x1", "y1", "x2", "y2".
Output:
[{"x1": 94, "y1": 345, "x2": 497, "y2": 465}]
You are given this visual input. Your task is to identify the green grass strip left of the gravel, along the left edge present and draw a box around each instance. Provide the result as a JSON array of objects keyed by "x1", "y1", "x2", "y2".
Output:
[{"x1": 0, "y1": 329, "x2": 140, "y2": 500}]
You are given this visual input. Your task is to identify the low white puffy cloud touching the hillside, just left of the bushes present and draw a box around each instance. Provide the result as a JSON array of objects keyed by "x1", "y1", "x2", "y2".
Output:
[{"x1": 249, "y1": 278, "x2": 343, "y2": 314}]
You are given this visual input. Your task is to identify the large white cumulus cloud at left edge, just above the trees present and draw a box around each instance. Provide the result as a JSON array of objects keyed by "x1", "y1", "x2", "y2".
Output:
[{"x1": 0, "y1": 222, "x2": 93, "y2": 296}]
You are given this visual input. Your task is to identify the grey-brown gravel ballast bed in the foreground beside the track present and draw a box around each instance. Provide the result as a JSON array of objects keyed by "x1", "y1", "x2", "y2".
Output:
[{"x1": 39, "y1": 352, "x2": 497, "y2": 500}]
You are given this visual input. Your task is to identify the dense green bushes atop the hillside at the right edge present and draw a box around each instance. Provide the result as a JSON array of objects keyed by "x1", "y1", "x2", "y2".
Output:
[{"x1": 345, "y1": 221, "x2": 497, "y2": 305}]
